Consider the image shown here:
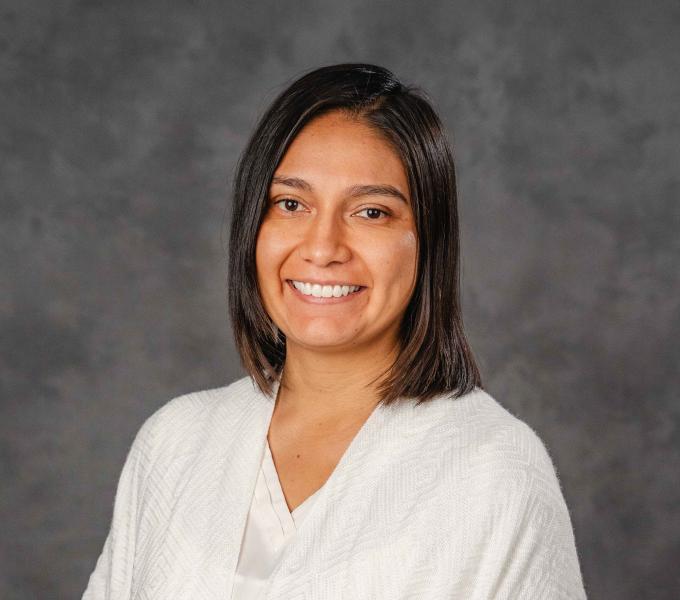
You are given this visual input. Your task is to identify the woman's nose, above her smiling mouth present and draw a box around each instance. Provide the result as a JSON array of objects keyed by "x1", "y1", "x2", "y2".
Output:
[{"x1": 298, "y1": 211, "x2": 352, "y2": 267}]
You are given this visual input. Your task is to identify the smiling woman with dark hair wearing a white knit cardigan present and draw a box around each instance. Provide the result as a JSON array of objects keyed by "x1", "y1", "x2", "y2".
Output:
[{"x1": 84, "y1": 64, "x2": 585, "y2": 600}]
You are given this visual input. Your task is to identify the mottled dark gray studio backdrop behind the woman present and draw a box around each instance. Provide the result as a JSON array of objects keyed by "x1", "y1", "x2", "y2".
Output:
[{"x1": 0, "y1": 0, "x2": 680, "y2": 600}]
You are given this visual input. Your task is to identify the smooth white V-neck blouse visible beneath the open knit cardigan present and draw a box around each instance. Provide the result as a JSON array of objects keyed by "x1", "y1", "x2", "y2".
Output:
[{"x1": 231, "y1": 441, "x2": 321, "y2": 600}]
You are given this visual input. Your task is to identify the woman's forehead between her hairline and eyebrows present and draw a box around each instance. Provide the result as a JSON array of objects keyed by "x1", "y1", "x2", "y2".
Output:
[{"x1": 276, "y1": 111, "x2": 408, "y2": 194}]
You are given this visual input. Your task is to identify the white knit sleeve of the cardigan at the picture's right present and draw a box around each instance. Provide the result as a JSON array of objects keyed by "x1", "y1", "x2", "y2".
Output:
[{"x1": 471, "y1": 423, "x2": 586, "y2": 600}]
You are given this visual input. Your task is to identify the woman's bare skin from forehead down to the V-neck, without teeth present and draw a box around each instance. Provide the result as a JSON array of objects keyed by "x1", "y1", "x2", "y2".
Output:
[{"x1": 256, "y1": 111, "x2": 418, "y2": 510}]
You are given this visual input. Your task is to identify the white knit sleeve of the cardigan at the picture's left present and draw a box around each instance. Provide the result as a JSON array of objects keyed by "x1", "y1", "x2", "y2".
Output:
[{"x1": 82, "y1": 415, "x2": 156, "y2": 600}]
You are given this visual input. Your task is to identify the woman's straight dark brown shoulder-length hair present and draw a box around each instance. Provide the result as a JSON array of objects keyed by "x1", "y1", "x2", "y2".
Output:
[{"x1": 228, "y1": 63, "x2": 482, "y2": 405}]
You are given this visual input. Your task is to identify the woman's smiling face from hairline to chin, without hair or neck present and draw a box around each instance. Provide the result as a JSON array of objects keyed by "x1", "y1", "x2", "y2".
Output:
[{"x1": 256, "y1": 111, "x2": 418, "y2": 351}]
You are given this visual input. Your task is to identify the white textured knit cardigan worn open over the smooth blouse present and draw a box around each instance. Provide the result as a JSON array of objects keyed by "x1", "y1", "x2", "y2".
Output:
[{"x1": 83, "y1": 377, "x2": 585, "y2": 600}]
